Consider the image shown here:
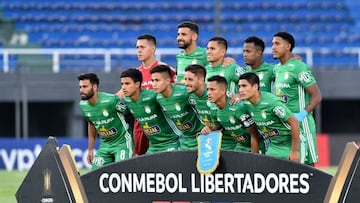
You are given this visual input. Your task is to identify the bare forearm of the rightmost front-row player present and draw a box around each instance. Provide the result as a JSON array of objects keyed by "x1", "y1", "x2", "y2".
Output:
[{"x1": 286, "y1": 115, "x2": 300, "y2": 162}]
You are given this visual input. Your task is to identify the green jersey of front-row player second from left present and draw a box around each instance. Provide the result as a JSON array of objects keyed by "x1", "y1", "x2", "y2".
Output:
[{"x1": 124, "y1": 89, "x2": 180, "y2": 154}]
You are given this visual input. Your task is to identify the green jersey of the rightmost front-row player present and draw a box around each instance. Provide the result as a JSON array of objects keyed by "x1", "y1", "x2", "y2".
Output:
[{"x1": 244, "y1": 92, "x2": 292, "y2": 159}]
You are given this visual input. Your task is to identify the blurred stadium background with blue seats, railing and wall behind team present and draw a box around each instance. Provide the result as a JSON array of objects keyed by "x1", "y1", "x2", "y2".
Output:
[{"x1": 0, "y1": 0, "x2": 360, "y2": 170}]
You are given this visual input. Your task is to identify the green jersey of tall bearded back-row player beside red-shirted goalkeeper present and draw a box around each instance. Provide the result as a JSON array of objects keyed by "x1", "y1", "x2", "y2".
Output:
[{"x1": 176, "y1": 47, "x2": 208, "y2": 83}]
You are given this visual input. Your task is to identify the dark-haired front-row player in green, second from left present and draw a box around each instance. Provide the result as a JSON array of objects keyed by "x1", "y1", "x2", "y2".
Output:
[{"x1": 121, "y1": 69, "x2": 180, "y2": 154}]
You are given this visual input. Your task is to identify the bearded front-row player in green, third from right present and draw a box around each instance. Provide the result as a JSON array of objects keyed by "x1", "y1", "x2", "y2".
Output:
[{"x1": 185, "y1": 64, "x2": 236, "y2": 150}]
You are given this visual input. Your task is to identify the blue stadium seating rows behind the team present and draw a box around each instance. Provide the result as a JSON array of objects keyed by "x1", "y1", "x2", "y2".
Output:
[{"x1": 0, "y1": 0, "x2": 360, "y2": 70}]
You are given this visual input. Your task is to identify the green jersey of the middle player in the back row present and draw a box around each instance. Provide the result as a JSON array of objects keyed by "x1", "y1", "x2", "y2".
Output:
[{"x1": 205, "y1": 63, "x2": 246, "y2": 95}]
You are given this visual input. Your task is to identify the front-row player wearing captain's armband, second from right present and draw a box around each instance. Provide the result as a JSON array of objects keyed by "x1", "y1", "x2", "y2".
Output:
[{"x1": 204, "y1": 76, "x2": 265, "y2": 153}]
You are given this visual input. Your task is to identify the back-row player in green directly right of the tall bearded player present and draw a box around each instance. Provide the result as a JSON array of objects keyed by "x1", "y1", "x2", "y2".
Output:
[{"x1": 205, "y1": 37, "x2": 245, "y2": 95}]
